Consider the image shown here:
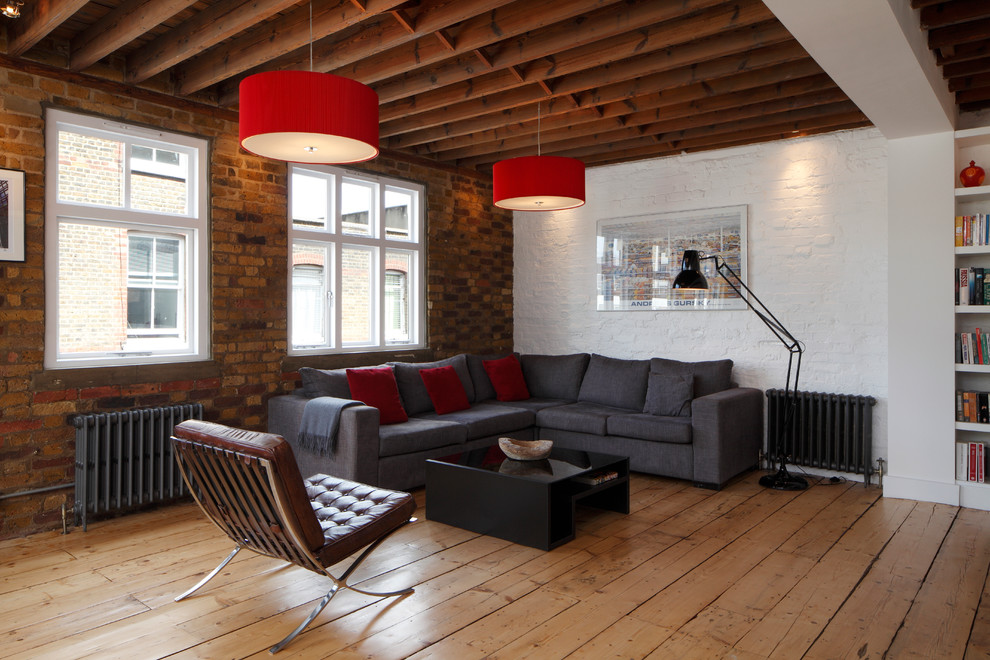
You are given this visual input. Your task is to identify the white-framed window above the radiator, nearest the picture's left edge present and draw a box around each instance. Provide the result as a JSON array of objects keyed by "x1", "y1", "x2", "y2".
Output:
[{"x1": 45, "y1": 109, "x2": 209, "y2": 368}]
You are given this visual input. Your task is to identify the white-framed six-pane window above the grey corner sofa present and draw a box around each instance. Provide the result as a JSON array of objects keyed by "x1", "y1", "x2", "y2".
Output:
[{"x1": 289, "y1": 165, "x2": 425, "y2": 355}]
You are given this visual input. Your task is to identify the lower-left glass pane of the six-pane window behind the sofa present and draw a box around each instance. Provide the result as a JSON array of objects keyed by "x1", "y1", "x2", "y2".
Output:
[{"x1": 292, "y1": 243, "x2": 330, "y2": 348}]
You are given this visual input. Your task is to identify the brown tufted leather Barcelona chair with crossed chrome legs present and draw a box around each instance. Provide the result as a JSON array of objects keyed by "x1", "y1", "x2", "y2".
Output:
[{"x1": 172, "y1": 420, "x2": 416, "y2": 653}]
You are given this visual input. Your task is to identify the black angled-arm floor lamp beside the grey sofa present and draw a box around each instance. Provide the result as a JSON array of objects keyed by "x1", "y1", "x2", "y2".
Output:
[{"x1": 673, "y1": 250, "x2": 808, "y2": 490}]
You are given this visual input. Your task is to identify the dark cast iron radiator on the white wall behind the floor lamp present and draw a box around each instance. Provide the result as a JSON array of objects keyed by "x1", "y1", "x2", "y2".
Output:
[{"x1": 767, "y1": 390, "x2": 877, "y2": 483}]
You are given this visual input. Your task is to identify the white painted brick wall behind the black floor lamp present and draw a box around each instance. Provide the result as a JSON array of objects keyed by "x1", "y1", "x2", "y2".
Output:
[{"x1": 514, "y1": 129, "x2": 888, "y2": 470}]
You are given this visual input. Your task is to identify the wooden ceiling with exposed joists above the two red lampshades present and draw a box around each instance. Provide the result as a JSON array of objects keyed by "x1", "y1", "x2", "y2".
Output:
[{"x1": 2, "y1": 0, "x2": 876, "y2": 171}]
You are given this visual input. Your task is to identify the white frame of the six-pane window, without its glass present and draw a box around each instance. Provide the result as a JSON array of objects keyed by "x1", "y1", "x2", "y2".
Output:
[{"x1": 286, "y1": 164, "x2": 426, "y2": 355}]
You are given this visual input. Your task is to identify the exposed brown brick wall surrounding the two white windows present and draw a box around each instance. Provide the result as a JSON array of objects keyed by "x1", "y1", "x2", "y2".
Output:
[{"x1": 0, "y1": 62, "x2": 513, "y2": 538}]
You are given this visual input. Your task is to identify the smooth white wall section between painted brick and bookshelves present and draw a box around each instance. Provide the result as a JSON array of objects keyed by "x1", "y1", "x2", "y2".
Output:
[{"x1": 884, "y1": 132, "x2": 959, "y2": 504}]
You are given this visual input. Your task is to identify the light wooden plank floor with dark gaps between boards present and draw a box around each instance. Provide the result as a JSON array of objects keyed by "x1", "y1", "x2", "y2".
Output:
[{"x1": 0, "y1": 474, "x2": 990, "y2": 660}]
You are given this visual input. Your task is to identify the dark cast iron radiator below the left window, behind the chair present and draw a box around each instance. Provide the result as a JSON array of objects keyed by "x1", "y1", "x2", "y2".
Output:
[{"x1": 72, "y1": 403, "x2": 203, "y2": 531}]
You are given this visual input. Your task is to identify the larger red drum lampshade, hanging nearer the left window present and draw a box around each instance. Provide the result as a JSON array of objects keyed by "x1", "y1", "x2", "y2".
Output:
[{"x1": 240, "y1": 71, "x2": 378, "y2": 163}]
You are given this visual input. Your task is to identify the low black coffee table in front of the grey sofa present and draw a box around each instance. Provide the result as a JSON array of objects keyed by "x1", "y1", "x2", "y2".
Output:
[{"x1": 426, "y1": 445, "x2": 629, "y2": 550}]
